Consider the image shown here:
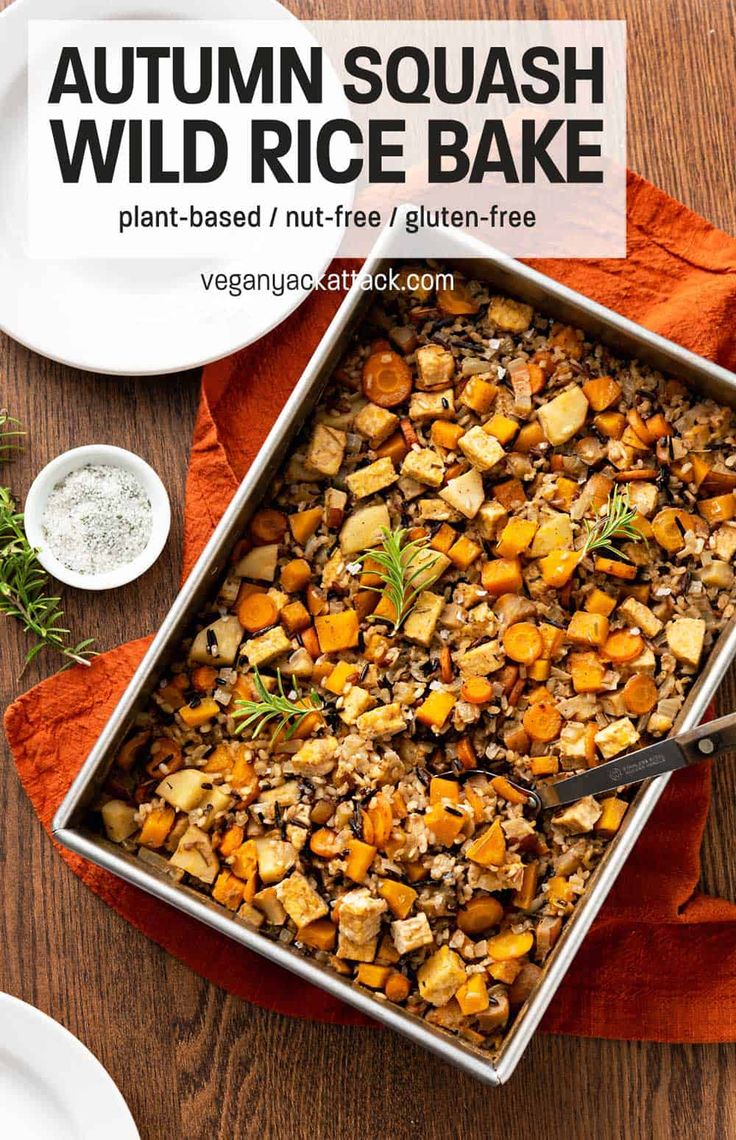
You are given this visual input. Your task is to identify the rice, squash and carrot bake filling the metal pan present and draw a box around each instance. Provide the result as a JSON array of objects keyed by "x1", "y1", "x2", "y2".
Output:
[{"x1": 95, "y1": 270, "x2": 736, "y2": 1052}]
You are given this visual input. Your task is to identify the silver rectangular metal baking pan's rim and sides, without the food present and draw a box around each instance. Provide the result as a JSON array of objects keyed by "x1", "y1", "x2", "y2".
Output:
[{"x1": 54, "y1": 217, "x2": 736, "y2": 1084}]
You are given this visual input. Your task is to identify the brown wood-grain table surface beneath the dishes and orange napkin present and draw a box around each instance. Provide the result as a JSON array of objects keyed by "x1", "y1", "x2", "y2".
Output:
[{"x1": 0, "y1": 0, "x2": 736, "y2": 1140}]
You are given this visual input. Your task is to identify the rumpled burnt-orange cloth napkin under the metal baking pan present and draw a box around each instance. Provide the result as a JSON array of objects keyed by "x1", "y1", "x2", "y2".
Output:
[{"x1": 6, "y1": 176, "x2": 736, "y2": 1042}]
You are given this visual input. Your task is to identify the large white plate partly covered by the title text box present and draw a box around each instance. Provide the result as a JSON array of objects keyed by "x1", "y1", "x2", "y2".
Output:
[{"x1": 0, "y1": 0, "x2": 332, "y2": 375}]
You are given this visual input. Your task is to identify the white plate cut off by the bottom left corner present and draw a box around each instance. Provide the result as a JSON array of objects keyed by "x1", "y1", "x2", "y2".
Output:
[{"x1": 0, "y1": 994, "x2": 140, "y2": 1140}]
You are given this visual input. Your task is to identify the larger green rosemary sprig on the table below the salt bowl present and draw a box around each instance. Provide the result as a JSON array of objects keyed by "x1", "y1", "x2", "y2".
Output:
[{"x1": 0, "y1": 487, "x2": 95, "y2": 668}]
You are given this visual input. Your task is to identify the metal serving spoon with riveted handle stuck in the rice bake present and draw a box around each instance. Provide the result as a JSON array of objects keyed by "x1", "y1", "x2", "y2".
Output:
[{"x1": 464, "y1": 713, "x2": 736, "y2": 814}]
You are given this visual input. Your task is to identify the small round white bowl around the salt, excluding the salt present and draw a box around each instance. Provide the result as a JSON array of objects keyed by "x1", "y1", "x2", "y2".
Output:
[{"x1": 25, "y1": 443, "x2": 171, "y2": 589}]
